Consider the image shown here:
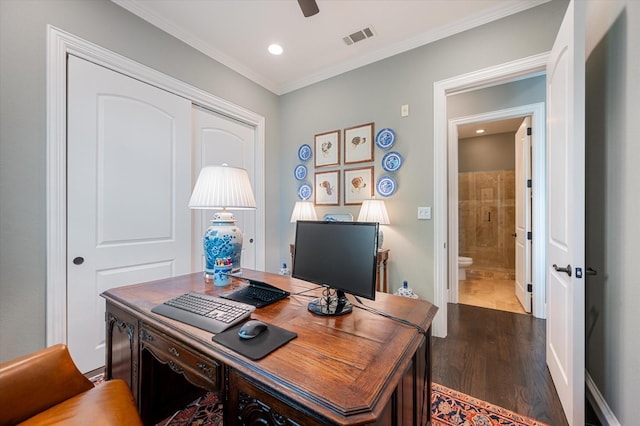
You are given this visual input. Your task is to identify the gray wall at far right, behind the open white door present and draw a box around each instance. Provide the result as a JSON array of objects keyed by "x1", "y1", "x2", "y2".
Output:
[{"x1": 585, "y1": 0, "x2": 640, "y2": 425}]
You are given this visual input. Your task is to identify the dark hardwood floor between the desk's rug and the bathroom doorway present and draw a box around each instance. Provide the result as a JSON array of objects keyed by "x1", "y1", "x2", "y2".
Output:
[{"x1": 432, "y1": 304, "x2": 567, "y2": 426}]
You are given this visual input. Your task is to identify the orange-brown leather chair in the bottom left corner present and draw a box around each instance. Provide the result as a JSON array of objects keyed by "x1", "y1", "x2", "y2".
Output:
[{"x1": 0, "y1": 345, "x2": 142, "y2": 426}]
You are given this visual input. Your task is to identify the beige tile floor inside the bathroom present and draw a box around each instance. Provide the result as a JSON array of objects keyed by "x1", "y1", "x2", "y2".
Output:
[{"x1": 458, "y1": 278, "x2": 526, "y2": 314}]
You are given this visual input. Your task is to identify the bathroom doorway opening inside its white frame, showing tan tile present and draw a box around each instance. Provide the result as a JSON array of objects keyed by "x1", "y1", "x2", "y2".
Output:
[{"x1": 458, "y1": 116, "x2": 531, "y2": 314}]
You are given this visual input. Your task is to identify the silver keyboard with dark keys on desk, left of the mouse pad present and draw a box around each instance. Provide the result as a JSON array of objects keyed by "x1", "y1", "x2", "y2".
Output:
[{"x1": 151, "y1": 292, "x2": 256, "y2": 333}]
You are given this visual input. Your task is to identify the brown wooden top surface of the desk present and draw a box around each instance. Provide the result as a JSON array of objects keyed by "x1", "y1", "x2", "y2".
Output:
[{"x1": 103, "y1": 269, "x2": 437, "y2": 423}]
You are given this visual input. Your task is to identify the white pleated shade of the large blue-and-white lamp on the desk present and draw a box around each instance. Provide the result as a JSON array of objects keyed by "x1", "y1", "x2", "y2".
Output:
[{"x1": 189, "y1": 164, "x2": 256, "y2": 210}]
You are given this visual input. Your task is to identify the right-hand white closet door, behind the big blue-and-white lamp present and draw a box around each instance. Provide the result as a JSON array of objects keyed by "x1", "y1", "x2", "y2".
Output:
[{"x1": 193, "y1": 107, "x2": 260, "y2": 271}]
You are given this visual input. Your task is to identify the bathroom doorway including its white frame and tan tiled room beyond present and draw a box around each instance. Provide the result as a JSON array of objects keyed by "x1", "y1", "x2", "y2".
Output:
[{"x1": 449, "y1": 103, "x2": 545, "y2": 313}]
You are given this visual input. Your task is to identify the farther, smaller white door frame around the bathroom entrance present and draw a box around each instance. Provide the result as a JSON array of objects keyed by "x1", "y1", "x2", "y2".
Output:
[{"x1": 448, "y1": 102, "x2": 547, "y2": 318}]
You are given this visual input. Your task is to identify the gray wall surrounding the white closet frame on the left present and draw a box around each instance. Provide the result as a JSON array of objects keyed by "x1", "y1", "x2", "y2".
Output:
[{"x1": 0, "y1": 0, "x2": 280, "y2": 362}]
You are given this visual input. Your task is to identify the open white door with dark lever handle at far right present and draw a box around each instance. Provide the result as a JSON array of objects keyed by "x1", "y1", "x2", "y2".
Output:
[{"x1": 546, "y1": 1, "x2": 585, "y2": 425}]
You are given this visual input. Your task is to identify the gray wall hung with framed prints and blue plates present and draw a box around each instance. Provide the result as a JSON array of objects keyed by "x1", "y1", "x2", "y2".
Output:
[{"x1": 280, "y1": 1, "x2": 567, "y2": 300}]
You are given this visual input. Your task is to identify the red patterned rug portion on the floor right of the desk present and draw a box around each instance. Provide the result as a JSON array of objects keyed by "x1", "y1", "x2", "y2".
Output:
[{"x1": 431, "y1": 383, "x2": 548, "y2": 426}]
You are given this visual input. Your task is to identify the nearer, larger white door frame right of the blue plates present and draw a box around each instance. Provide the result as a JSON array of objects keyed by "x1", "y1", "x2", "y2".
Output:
[{"x1": 433, "y1": 52, "x2": 549, "y2": 337}]
